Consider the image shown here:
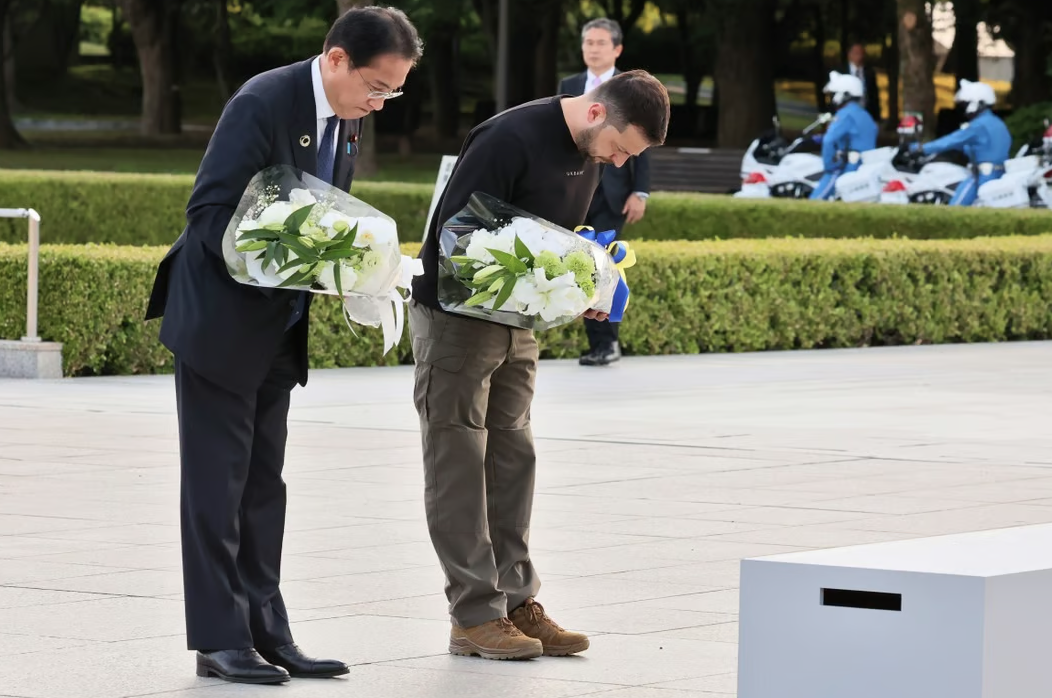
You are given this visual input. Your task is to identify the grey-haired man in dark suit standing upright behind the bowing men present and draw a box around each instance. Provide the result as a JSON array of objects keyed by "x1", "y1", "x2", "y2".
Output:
[{"x1": 559, "y1": 18, "x2": 650, "y2": 366}]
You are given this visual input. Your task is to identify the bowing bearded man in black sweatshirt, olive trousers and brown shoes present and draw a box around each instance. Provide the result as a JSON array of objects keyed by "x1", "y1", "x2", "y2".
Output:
[{"x1": 409, "y1": 71, "x2": 669, "y2": 659}]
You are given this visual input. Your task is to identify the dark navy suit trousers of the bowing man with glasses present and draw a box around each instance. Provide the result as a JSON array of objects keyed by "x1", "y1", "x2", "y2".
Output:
[{"x1": 176, "y1": 333, "x2": 298, "y2": 650}]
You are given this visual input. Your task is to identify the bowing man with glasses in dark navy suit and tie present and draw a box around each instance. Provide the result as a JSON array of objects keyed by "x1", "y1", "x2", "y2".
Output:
[{"x1": 146, "y1": 6, "x2": 422, "y2": 683}]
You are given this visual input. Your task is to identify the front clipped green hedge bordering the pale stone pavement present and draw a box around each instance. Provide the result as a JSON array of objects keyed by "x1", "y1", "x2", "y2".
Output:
[{"x1": 0, "y1": 236, "x2": 1052, "y2": 375}]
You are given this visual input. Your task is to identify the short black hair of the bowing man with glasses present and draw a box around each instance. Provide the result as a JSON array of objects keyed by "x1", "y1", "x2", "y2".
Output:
[{"x1": 324, "y1": 5, "x2": 424, "y2": 67}]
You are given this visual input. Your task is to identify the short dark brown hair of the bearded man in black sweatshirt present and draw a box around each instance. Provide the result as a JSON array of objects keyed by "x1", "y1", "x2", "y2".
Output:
[{"x1": 591, "y1": 71, "x2": 670, "y2": 145}]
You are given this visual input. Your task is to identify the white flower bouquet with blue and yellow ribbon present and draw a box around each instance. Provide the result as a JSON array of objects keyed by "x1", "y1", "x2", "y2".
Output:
[{"x1": 439, "y1": 192, "x2": 634, "y2": 330}]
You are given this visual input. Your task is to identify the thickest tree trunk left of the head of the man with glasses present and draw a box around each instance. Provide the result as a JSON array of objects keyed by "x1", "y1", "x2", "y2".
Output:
[{"x1": 123, "y1": 0, "x2": 181, "y2": 136}]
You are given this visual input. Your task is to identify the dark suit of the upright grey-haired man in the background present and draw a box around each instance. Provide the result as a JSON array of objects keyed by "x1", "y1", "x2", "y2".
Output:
[{"x1": 559, "y1": 69, "x2": 650, "y2": 360}]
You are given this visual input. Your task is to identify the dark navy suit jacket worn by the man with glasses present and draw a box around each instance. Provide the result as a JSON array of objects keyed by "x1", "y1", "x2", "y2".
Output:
[{"x1": 146, "y1": 59, "x2": 361, "y2": 393}]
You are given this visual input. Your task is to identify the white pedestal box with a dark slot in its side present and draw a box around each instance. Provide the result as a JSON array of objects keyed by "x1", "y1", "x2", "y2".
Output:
[{"x1": 737, "y1": 525, "x2": 1052, "y2": 698}]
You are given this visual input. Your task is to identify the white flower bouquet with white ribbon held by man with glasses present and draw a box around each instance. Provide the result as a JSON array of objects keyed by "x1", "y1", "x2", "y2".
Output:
[{"x1": 223, "y1": 165, "x2": 423, "y2": 354}]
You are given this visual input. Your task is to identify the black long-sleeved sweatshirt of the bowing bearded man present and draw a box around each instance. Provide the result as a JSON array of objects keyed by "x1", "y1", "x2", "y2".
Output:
[{"x1": 412, "y1": 96, "x2": 600, "y2": 310}]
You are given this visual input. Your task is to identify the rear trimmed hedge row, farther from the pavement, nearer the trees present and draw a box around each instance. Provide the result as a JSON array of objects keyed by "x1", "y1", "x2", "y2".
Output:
[{"x1": 0, "y1": 171, "x2": 1052, "y2": 245}]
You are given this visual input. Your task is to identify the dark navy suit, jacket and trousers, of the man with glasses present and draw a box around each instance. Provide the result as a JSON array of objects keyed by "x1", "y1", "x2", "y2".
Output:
[{"x1": 146, "y1": 59, "x2": 361, "y2": 650}]
